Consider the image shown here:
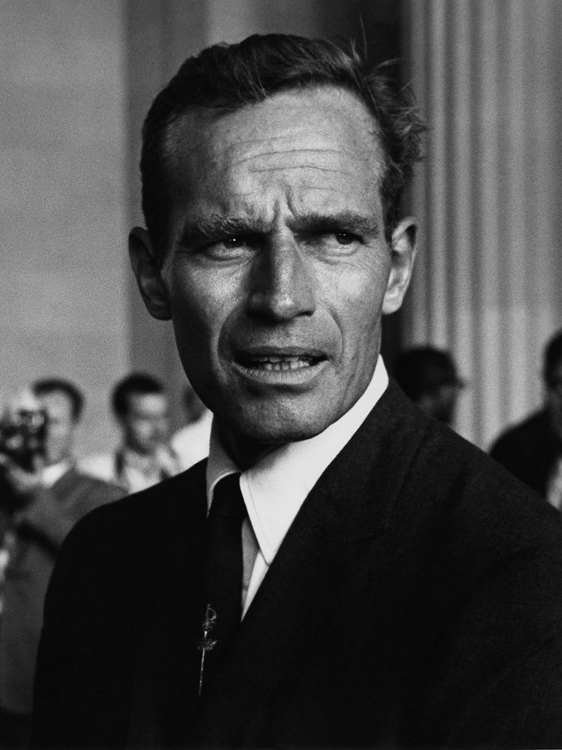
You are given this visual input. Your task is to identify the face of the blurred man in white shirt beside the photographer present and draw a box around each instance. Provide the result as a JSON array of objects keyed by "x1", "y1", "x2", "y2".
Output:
[{"x1": 121, "y1": 393, "x2": 169, "y2": 455}]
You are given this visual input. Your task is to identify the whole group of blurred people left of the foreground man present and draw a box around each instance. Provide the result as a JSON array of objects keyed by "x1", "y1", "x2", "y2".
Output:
[{"x1": 0, "y1": 373, "x2": 211, "y2": 747}]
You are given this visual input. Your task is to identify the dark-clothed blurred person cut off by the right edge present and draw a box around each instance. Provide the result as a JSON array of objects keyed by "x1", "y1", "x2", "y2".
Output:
[{"x1": 490, "y1": 330, "x2": 562, "y2": 509}]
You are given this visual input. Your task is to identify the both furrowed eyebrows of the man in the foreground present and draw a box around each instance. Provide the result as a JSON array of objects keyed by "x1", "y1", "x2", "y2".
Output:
[{"x1": 179, "y1": 211, "x2": 380, "y2": 246}]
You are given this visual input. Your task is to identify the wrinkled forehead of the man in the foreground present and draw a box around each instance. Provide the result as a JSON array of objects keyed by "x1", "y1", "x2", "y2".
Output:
[{"x1": 162, "y1": 87, "x2": 383, "y2": 206}]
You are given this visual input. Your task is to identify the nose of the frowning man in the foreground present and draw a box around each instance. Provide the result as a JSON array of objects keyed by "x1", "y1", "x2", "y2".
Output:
[{"x1": 248, "y1": 236, "x2": 316, "y2": 323}]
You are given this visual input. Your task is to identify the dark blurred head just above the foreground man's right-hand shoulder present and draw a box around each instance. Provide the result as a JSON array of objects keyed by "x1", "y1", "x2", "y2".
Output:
[{"x1": 392, "y1": 346, "x2": 464, "y2": 426}]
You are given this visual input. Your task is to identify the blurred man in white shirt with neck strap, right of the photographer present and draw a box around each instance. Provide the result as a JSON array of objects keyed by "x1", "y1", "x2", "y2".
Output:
[{"x1": 80, "y1": 373, "x2": 182, "y2": 493}]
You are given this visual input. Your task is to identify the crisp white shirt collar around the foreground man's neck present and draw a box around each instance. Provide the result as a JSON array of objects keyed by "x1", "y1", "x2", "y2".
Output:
[{"x1": 207, "y1": 356, "x2": 388, "y2": 564}]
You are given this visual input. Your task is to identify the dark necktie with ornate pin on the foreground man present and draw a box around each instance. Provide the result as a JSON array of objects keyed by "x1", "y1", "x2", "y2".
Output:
[{"x1": 199, "y1": 474, "x2": 246, "y2": 686}]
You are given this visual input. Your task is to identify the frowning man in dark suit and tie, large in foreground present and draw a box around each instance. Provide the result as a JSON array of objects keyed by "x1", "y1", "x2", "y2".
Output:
[{"x1": 31, "y1": 36, "x2": 562, "y2": 748}]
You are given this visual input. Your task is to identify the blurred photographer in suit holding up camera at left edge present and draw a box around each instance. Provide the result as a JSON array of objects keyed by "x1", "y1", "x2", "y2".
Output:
[{"x1": 0, "y1": 378, "x2": 123, "y2": 748}]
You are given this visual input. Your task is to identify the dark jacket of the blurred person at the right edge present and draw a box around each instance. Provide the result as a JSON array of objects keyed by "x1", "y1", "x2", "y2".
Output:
[{"x1": 490, "y1": 409, "x2": 562, "y2": 497}]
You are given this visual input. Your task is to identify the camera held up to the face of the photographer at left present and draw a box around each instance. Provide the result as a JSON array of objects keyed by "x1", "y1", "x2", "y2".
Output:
[{"x1": 0, "y1": 393, "x2": 47, "y2": 471}]
